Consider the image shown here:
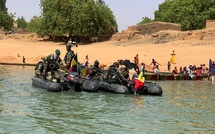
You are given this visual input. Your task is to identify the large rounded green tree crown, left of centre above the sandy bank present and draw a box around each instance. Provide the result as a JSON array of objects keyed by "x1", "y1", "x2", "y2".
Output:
[{"x1": 40, "y1": 0, "x2": 117, "y2": 37}]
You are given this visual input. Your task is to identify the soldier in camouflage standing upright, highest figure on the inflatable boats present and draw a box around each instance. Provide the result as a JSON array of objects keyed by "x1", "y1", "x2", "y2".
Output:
[{"x1": 63, "y1": 43, "x2": 75, "y2": 70}]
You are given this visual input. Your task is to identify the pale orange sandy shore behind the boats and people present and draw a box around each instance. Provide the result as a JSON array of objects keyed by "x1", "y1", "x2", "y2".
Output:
[{"x1": 0, "y1": 39, "x2": 215, "y2": 71}]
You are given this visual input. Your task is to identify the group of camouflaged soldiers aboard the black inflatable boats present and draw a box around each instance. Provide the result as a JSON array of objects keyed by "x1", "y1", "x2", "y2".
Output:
[{"x1": 35, "y1": 47, "x2": 149, "y2": 95}]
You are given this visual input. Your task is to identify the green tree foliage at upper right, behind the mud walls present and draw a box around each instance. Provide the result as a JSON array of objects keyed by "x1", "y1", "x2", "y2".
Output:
[{"x1": 154, "y1": 0, "x2": 215, "y2": 30}]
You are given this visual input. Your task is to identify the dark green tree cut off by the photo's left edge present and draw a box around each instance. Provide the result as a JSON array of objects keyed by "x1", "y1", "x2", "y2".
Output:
[{"x1": 0, "y1": 0, "x2": 13, "y2": 30}]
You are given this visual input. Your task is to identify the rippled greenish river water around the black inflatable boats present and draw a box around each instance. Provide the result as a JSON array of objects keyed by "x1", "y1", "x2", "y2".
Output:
[{"x1": 0, "y1": 65, "x2": 215, "y2": 134}]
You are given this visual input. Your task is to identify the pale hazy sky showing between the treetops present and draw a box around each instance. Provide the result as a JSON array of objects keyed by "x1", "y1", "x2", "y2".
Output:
[{"x1": 6, "y1": 0, "x2": 165, "y2": 31}]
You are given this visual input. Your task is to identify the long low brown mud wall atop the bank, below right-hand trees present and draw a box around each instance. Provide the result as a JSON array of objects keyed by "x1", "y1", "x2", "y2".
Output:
[{"x1": 127, "y1": 22, "x2": 181, "y2": 35}]
